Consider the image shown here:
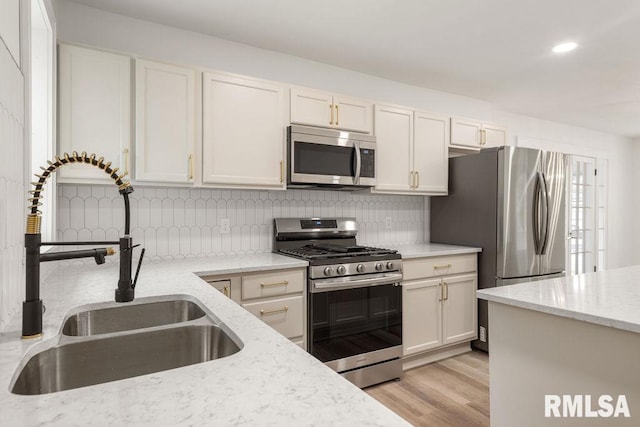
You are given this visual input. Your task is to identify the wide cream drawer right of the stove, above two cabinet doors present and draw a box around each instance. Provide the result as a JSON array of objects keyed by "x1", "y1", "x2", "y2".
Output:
[{"x1": 402, "y1": 253, "x2": 477, "y2": 281}]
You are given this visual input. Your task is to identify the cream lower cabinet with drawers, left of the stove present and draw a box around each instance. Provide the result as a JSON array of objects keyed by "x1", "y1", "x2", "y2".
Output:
[{"x1": 203, "y1": 268, "x2": 307, "y2": 349}]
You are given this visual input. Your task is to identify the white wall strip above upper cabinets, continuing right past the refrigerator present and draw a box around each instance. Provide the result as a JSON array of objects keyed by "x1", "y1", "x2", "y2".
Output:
[{"x1": 55, "y1": 0, "x2": 640, "y2": 268}]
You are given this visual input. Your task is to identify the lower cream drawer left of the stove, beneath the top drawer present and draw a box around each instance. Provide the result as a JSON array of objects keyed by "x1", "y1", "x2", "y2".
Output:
[{"x1": 242, "y1": 295, "x2": 304, "y2": 338}]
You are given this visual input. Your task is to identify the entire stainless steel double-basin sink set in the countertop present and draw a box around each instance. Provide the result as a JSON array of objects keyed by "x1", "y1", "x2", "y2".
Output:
[{"x1": 10, "y1": 295, "x2": 243, "y2": 395}]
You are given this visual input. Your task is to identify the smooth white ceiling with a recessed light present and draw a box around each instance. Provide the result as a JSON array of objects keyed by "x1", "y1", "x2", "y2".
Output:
[{"x1": 67, "y1": 0, "x2": 640, "y2": 137}]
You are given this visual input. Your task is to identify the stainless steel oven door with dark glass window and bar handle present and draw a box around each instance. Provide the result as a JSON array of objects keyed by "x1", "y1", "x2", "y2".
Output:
[{"x1": 308, "y1": 273, "x2": 402, "y2": 372}]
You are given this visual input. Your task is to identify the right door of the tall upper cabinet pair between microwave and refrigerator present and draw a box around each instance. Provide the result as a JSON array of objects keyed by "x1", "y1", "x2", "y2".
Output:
[{"x1": 413, "y1": 111, "x2": 449, "y2": 194}]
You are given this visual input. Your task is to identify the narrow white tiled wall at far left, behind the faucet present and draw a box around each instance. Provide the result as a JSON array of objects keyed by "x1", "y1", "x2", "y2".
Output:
[{"x1": 0, "y1": 0, "x2": 26, "y2": 330}]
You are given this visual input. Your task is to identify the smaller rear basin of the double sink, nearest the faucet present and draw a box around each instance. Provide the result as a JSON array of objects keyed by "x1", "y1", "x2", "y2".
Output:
[{"x1": 62, "y1": 298, "x2": 205, "y2": 336}]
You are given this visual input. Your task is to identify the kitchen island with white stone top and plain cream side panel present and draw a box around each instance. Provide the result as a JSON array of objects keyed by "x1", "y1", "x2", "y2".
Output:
[{"x1": 477, "y1": 266, "x2": 640, "y2": 427}]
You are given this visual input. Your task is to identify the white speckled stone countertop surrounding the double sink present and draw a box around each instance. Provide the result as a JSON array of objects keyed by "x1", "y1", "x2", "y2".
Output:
[{"x1": 0, "y1": 254, "x2": 408, "y2": 426}]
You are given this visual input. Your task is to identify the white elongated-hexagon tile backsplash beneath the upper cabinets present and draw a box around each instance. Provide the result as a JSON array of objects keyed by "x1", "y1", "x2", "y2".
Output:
[{"x1": 58, "y1": 184, "x2": 428, "y2": 259}]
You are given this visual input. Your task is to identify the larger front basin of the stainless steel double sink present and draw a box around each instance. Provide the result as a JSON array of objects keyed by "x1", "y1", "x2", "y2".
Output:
[{"x1": 11, "y1": 325, "x2": 240, "y2": 395}]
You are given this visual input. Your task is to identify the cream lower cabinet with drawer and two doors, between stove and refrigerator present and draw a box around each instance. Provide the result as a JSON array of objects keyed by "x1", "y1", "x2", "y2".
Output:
[{"x1": 402, "y1": 254, "x2": 477, "y2": 357}]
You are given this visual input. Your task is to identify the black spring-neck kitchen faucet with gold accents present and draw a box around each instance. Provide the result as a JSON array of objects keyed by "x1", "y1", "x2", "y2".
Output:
[{"x1": 22, "y1": 151, "x2": 144, "y2": 338}]
